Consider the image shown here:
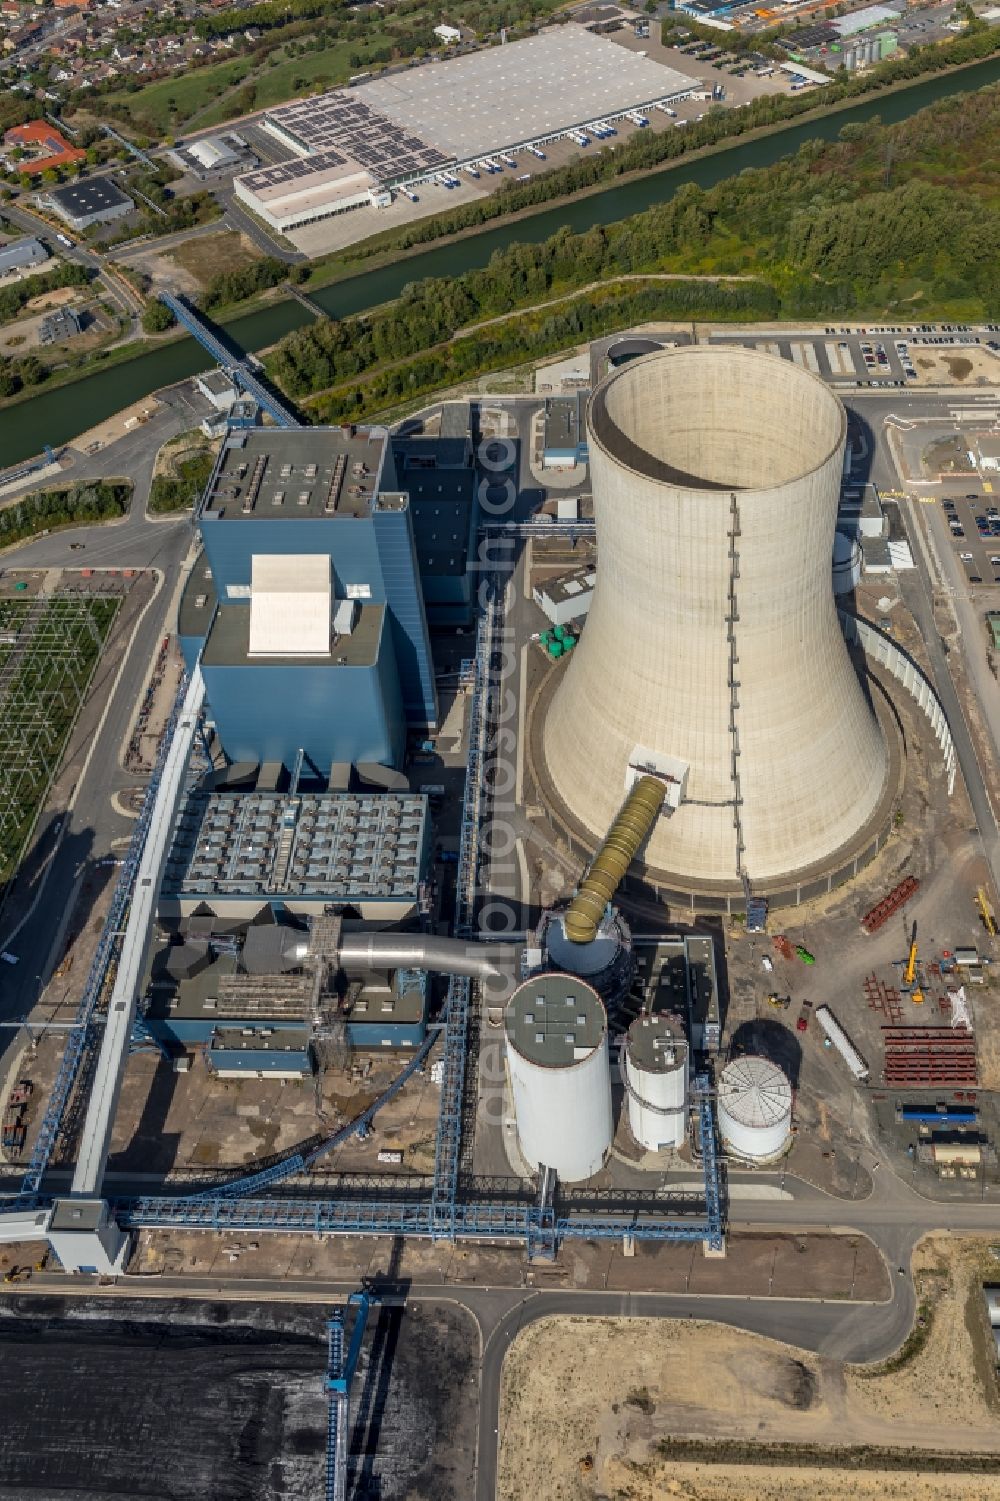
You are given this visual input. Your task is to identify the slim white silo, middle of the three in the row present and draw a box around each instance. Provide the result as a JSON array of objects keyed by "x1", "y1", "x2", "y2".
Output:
[{"x1": 622, "y1": 1015, "x2": 688, "y2": 1151}]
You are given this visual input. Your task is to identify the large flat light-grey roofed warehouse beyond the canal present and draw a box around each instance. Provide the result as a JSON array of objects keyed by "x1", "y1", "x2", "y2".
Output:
[{"x1": 236, "y1": 24, "x2": 697, "y2": 230}]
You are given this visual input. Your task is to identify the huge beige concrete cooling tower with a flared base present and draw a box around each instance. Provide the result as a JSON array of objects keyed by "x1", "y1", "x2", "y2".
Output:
[{"x1": 542, "y1": 347, "x2": 889, "y2": 892}]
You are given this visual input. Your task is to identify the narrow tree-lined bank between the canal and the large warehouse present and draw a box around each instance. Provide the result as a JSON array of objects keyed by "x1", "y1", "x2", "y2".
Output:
[{"x1": 312, "y1": 27, "x2": 1000, "y2": 267}]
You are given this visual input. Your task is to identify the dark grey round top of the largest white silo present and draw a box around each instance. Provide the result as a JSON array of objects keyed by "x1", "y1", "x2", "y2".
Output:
[{"x1": 503, "y1": 974, "x2": 608, "y2": 1069}]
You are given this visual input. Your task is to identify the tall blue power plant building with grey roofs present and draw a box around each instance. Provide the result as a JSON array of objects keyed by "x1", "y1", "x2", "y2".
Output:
[{"x1": 179, "y1": 417, "x2": 476, "y2": 781}]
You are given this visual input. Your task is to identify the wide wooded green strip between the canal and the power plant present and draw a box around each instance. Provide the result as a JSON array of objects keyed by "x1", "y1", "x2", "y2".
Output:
[{"x1": 267, "y1": 86, "x2": 1000, "y2": 420}]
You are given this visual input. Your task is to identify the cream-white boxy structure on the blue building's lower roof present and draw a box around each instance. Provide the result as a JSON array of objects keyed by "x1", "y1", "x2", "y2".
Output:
[{"x1": 248, "y1": 552, "x2": 333, "y2": 657}]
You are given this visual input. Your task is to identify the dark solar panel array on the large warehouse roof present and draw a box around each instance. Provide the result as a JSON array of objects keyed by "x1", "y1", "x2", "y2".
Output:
[{"x1": 264, "y1": 90, "x2": 447, "y2": 186}]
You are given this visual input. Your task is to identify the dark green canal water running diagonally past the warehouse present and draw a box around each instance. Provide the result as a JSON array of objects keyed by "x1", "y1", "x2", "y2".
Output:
[{"x1": 0, "y1": 57, "x2": 1000, "y2": 468}]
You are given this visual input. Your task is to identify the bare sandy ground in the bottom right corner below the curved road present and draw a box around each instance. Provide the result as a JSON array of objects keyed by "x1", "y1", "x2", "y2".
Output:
[{"x1": 498, "y1": 1237, "x2": 1000, "y2": 1501}]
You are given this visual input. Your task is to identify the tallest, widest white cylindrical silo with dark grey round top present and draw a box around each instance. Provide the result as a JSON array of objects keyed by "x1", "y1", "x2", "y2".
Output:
[{"x1": 505, "y1": 974, "x2": 613, "y2": 1183}]
